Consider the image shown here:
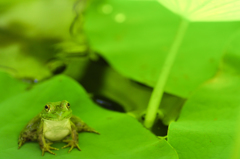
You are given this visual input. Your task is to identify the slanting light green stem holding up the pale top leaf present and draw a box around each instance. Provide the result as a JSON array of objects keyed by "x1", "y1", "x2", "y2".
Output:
[{"x1": 144, "y1": 19, "x2": 188, "y2": 129}]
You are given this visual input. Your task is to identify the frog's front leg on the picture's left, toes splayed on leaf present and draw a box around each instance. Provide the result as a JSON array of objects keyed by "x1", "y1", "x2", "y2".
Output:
[{"x1": 38, "y1": 121, "x2": 58, "y2": 156}]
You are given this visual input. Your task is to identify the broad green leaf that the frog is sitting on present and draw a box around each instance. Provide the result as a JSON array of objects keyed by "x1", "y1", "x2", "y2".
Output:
[{"x1": 0, "y1": 76, "x2": 178, "y2": 159}]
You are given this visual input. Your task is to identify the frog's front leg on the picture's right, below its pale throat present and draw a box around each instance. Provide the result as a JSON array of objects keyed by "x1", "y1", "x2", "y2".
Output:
[{"x1": 62, "y1": 121, "x2": 81, "y2": 153}]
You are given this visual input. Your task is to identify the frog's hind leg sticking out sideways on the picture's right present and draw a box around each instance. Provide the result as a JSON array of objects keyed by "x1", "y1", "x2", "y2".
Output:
[{"x1": 71, "y1": 115, "x2": 100, "y2": 134}]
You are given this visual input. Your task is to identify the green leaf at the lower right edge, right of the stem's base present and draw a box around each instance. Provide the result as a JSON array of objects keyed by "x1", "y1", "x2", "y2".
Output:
[{"x1": 168, "y1": 44, "x2": 240, "y2": 159}]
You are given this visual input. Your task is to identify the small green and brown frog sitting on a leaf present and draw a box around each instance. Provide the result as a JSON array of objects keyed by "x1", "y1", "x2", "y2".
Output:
[{"x1": 18, "y1": 100, "x2": 99, "y2": 156}]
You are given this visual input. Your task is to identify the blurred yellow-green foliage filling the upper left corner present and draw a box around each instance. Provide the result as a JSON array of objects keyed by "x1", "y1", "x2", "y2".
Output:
[{"x1": 0, "y1": 0, "x2": 87, "y2": 80}]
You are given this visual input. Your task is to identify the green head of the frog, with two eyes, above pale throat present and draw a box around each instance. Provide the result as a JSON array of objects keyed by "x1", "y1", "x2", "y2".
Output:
[{"x1": 40, "y1": 100, "x2": 72, "y2": 121}]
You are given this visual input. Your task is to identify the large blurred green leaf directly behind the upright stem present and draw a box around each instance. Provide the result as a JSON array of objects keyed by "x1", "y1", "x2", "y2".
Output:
[{"x1": 85, "y1": 0, "x2": 240, "y2": 97}]
